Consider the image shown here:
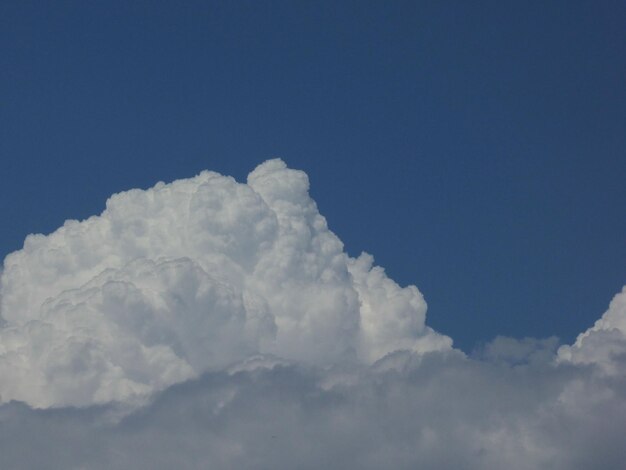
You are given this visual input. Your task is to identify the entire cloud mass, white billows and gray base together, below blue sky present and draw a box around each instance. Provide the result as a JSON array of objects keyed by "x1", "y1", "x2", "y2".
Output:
[{"x1": 0, "y1": 160, "x2": 626, "y2": 469}]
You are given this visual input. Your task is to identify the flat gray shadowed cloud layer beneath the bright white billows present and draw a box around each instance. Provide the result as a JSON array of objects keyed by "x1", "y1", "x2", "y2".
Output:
[{"x1": 0, "y1": 346, "x2": 626, "y2": 470}]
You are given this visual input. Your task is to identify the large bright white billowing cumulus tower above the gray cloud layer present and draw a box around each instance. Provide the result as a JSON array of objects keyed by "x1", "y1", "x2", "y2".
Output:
[{"x1": 0, "y1": 160, "x2": 451, "y2": 407}]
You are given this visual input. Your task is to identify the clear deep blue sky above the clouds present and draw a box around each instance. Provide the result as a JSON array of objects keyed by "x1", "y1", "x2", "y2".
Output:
[{"x1": 0, "y1": 0, "x2": 626, "y2": 350}]
